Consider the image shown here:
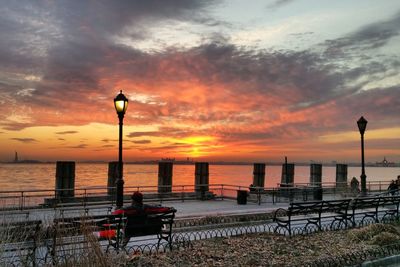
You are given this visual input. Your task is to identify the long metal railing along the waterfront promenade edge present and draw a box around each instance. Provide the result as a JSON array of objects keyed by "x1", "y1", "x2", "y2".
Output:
[{"x1": 0, "y1": 181, "x2": 389, "y2": 211}]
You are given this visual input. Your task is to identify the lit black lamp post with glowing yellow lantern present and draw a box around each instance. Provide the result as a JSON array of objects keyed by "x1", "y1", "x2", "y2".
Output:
[{"x1": 114, "y1": 90, "x2": 128, "y2": 208}]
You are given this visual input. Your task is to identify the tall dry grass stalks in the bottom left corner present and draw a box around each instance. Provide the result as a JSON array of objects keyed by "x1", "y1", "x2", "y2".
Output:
[{"x1": 0, "y1": 220, "x2": 127, "y2": 267}]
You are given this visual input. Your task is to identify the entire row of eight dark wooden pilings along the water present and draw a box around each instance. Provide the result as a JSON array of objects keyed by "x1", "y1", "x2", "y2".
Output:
[{"x1": 55, "y1": 161, "x2": 347, "y2": 197}]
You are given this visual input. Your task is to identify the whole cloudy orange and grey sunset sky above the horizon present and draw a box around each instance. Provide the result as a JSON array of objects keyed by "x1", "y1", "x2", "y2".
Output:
[{"x1": 0, "y1": 0, "x2": 400, "y2": 162}]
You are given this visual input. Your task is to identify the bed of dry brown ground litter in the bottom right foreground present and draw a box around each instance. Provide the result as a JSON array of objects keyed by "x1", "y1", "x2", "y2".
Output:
[{"x1": 130, "y1": 224, "x2": 399, "y2": 266}]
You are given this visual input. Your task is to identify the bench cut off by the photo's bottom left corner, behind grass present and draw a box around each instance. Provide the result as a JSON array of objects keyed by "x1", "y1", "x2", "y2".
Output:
[{"x1": 0, "y1": 220, "x2": 42, "y2": 266}]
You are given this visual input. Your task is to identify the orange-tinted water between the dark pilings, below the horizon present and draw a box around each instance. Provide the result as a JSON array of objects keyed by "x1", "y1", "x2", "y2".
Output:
[{"x1": 0, "y1": 162, "x2": 400, "y2": 191}]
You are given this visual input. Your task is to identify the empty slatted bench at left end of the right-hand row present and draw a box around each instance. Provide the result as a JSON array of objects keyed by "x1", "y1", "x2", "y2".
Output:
[{"x1": 273, "y1": 199, "x2": 350, "y2": 235}]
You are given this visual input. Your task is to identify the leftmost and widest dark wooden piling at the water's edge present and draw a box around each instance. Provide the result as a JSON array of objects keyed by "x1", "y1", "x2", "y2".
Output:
[{"x1": 55, "y1": 161, "x2": 75, "y2": 198}]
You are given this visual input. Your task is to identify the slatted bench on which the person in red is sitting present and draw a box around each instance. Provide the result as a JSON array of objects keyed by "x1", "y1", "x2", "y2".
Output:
[{"x1": 46, "y1": 208, "x2": 176, "y2": 259}]
